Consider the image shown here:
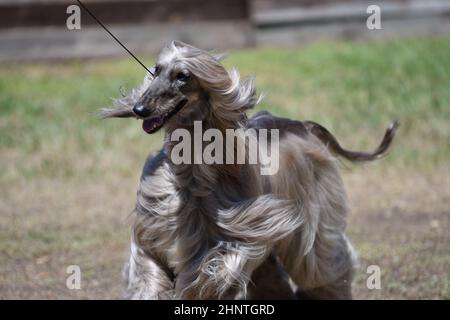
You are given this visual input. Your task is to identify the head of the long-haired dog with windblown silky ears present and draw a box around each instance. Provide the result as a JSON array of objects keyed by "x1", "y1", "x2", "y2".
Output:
[{"x1": 101, "y1": 41, "x2": 257, "y2": 133}]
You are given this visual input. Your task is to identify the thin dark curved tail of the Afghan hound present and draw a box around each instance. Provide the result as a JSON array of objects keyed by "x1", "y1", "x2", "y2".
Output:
[{"x1": 304, "y1": 120, "x2": 399, "y2": 162}]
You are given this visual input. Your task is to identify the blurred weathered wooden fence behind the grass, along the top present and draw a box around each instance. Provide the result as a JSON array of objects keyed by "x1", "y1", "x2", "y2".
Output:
[{"x1": 0, "y1": 0, "x2": 450, "y2": 61}]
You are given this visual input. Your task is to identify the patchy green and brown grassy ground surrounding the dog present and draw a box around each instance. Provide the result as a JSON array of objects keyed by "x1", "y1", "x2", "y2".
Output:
[{"x1": 0, "y1": 38, "x2": 450, "y2": 299}]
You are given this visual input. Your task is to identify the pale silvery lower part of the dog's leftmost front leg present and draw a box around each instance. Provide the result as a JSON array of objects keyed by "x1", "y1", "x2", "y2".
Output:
[{"x1": 124, "y1": 242, "x2": 173, "y2": 300}]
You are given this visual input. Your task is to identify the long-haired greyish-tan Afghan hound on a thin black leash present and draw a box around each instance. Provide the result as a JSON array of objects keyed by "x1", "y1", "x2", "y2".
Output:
[{"x1": 101, "y1": 41, "x2": 398, "y2": 299}]
